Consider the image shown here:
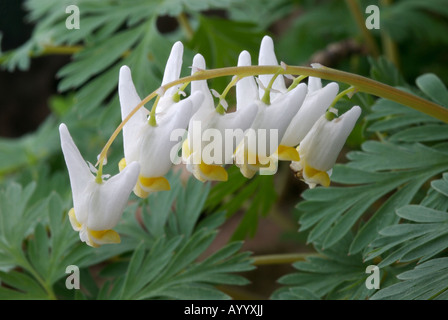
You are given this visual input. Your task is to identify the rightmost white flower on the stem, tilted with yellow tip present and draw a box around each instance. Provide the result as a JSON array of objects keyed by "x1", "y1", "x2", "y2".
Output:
[{"x1": 291, "y1": 106, "x2": 361, "y2": 188}]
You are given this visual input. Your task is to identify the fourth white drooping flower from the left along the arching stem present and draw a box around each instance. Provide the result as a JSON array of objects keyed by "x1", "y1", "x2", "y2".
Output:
[{"x1": 234, "y1": 36, "x2": 307, "y2": 178}]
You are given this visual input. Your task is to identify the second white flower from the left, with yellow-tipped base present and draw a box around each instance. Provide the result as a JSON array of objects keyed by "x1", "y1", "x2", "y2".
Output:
[{"x1": 118, "y1": 66, "x2": 203, "y2": 198}]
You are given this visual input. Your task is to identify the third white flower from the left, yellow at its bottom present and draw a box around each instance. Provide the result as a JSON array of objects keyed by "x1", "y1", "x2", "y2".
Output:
[{"x1": 182, "y1": 54, "x2": 258, "y2": 181}]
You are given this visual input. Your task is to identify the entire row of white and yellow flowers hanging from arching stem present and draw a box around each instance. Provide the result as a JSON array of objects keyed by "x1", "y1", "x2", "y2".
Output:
[{"x1": 59, "y1": 36, "x2": 361, "y2": 247}]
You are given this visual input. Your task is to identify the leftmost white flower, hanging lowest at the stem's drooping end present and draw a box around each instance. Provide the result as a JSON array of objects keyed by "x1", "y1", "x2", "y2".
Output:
[{"x1": 59, "y1": 124, "x2": 140, "y2": 247}]
